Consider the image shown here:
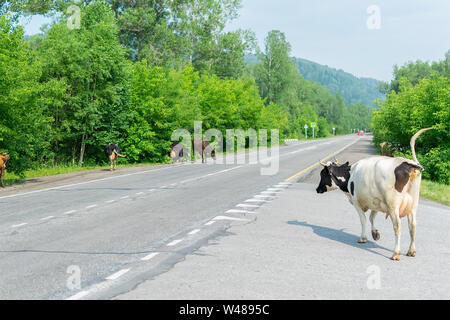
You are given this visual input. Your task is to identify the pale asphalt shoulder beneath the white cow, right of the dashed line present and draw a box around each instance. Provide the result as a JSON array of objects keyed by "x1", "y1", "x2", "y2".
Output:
[{"x1": 115, "y1": 137, "x2": 450, "y2": 300}]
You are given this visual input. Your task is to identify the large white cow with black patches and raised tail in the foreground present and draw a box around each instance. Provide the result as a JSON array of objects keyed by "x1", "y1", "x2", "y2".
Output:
[{"x1": 316, "y1": 128, "x2": 433, "y2": 260}]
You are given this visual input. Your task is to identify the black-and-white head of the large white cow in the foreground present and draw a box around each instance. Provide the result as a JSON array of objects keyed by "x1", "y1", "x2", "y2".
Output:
[{"x1": 316, "y1": 160, "x2": 351, "y2": 193}]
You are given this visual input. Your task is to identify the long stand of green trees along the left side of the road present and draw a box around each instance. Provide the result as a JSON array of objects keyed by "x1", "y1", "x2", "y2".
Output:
[{"x1": 0, "y1": 0, "x2": 371, "y2": 174}]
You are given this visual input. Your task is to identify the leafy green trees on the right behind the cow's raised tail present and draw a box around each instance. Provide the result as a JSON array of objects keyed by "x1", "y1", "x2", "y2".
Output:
[{"x1": 372, "y1": 51, "x2": 450, "y2": 185}]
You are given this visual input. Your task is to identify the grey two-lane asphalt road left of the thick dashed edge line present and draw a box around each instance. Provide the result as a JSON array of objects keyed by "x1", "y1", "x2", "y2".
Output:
[{"x1": 0, "y1": 135, "x2": 361, "y2": 299}]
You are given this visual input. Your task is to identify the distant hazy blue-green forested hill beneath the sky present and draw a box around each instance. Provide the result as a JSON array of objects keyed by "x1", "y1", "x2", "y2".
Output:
[{"x1": 245, "y1": 55, "x2": 385, "y2": 107}]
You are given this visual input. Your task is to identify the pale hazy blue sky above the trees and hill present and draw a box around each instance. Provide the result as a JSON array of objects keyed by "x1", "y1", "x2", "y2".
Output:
[{"x1": 19, "y1": 0, "x2": 450, "y2": 80}]
